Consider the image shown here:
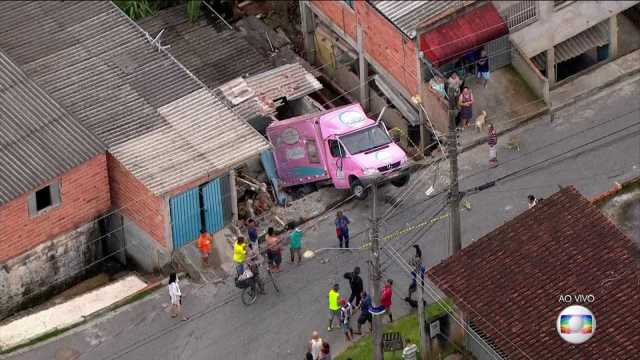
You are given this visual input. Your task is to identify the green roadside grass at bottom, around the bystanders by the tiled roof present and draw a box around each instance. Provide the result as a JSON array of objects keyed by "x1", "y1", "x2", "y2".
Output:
[{"x1": 335, "y1": 298, "x2": 455, "y2": 360}]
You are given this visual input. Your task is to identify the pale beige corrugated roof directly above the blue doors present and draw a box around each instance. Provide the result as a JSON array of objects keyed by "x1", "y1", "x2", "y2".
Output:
[{"x1": 110, "y1": 89, "x2": 268, "y2": 193}]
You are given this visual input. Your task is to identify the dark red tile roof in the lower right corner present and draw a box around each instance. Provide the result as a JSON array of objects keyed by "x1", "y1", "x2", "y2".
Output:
[{"x1": 429, "y1": 187, "x2": 640, "y2": 360}]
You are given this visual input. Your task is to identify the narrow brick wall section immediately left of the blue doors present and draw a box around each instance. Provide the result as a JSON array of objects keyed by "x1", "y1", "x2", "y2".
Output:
[{"x1": 107, "y1": 155, "x2": 167, "y2": 247}]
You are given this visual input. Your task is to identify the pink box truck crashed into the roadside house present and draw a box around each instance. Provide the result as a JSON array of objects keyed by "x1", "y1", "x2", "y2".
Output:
[{"x1": 267, "y1": 104, "x2": 409, "y2": 199}]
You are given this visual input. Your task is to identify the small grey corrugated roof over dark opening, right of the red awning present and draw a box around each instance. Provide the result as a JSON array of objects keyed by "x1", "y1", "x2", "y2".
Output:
[{"x1": 532, "y1": 22, "x2": 609, "y2": 69}]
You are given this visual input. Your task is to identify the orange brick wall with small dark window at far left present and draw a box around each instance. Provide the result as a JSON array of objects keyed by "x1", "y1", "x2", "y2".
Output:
[{"x1": 0, "y1": 154, "x2": 110, "y2": 262}]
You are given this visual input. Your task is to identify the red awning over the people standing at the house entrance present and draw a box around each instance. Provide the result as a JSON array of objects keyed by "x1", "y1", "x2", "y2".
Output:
[{"x1": 420, "y1": 3, "x2": 509, "y2": 66}]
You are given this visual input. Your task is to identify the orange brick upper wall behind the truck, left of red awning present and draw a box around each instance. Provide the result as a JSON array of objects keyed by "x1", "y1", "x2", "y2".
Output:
[{"x1": 313, "y1": 0, "x2": 418, "y2": 95}]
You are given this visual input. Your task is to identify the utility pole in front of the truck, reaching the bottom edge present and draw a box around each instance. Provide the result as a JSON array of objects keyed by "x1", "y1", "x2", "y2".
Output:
[{"x1": 369, "y1": 180, "x2": 383, "y2": 360}]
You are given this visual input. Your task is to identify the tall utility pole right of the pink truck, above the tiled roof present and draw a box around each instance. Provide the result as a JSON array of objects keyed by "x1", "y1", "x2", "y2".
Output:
[{"x1": 447, "y1": 87, "x2": 462, "y2": 255}]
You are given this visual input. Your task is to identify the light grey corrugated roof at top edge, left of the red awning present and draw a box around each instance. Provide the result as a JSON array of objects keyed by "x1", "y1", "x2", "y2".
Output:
[{"x1": 370, "y1": 0, "x2": 463, "y2": 39}]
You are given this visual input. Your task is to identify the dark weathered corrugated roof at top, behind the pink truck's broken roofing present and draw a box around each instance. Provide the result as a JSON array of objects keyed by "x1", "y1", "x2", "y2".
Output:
[{"x1": 138, "y1": 5, "x2": 274, "y2": 89}]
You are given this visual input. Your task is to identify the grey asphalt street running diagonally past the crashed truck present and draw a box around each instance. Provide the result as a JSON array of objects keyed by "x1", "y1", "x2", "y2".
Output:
[{"x1": 8, "y1": 78, "x2": 640, "y2": 360}]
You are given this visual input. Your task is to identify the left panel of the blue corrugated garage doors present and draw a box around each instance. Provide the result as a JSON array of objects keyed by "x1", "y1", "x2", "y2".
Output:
[{"x1": 169, "y1": 188, "x2": 201, "y2": 249}]
